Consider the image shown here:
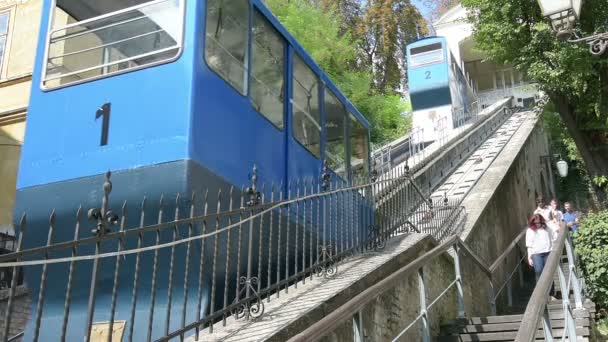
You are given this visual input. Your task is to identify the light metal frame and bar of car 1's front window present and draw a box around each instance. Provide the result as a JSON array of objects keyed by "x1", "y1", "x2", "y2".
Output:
[{"x1": 39, "y1": 0, "x2": 187, "y2": 92}]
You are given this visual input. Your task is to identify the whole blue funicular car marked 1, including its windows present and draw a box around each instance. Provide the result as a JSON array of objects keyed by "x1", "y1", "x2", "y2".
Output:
[{"x1": 15, "y1": 0, "x2": 370, "y2": 341}]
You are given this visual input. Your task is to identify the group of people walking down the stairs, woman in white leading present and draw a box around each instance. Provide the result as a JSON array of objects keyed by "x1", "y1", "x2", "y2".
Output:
[{"x1": 526, "y1": 197, "x2": 579, "y2": 298}]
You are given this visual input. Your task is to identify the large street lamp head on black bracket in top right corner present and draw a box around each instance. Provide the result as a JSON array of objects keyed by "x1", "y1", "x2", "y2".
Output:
[{"x1": 537, "y1": 0, "x2": 608, "y2": 55}]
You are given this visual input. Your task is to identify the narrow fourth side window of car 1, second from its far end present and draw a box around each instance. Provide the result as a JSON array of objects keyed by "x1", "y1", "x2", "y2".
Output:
[{"x1": 325, "y1": 91, "x2": 347, "y2": 179}]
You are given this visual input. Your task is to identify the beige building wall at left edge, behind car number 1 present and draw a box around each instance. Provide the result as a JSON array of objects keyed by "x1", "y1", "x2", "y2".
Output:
[{"x1": 0, "y1": 0, "x2": 42, "y2": 230}]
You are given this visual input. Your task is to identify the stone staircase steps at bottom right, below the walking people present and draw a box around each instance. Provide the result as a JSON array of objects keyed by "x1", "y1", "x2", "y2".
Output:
[{"x1": 435, "y1": 273, "x2": 595, "y2": 342}]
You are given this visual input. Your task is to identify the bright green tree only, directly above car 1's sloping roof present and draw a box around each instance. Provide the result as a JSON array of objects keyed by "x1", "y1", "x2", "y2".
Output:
[{"x1": 266, "y1": 0, "x2": 409, "y2": 143}]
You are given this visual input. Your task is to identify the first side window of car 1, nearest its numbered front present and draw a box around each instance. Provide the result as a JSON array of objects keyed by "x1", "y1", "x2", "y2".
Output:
[{"x1": 205, "y1": 0, "x2": 249, "y2": 95}]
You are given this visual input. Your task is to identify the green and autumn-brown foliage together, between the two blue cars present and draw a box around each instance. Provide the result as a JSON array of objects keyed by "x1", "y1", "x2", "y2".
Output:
[{"x1": 266, "y1": 0, "x2": 421, "y2": 143}]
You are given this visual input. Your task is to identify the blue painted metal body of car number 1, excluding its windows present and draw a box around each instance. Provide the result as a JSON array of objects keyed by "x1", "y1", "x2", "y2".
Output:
[{"x1": 15, "y1": 0, "x2": 369, "y2": 341}]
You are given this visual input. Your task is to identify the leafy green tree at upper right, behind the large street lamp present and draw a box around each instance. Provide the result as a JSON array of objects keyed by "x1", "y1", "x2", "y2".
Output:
[{"x1": 462, "y1": 0, "x2": 608, "y2": 206}]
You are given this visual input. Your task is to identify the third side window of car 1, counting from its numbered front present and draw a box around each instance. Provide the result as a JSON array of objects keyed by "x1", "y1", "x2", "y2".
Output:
[{"x1": 293, "y1": 55, "x2": 321, "y2": 157}]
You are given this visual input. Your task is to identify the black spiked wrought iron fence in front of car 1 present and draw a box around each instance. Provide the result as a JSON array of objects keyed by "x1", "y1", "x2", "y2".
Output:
[{"x1": 0, "y1": 166, "x2": 466, "y2": 341}]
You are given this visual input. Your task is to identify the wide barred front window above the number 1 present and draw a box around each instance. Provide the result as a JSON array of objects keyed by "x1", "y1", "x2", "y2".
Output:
[{"x1": 43, "y1": 0, "x2": 183, "y2": 88}]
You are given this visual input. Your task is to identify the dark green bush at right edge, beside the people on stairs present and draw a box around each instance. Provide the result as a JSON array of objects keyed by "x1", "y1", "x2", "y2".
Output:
[{"x1": 574, "y1": 210, "x2": 608, "y2": 308}]
